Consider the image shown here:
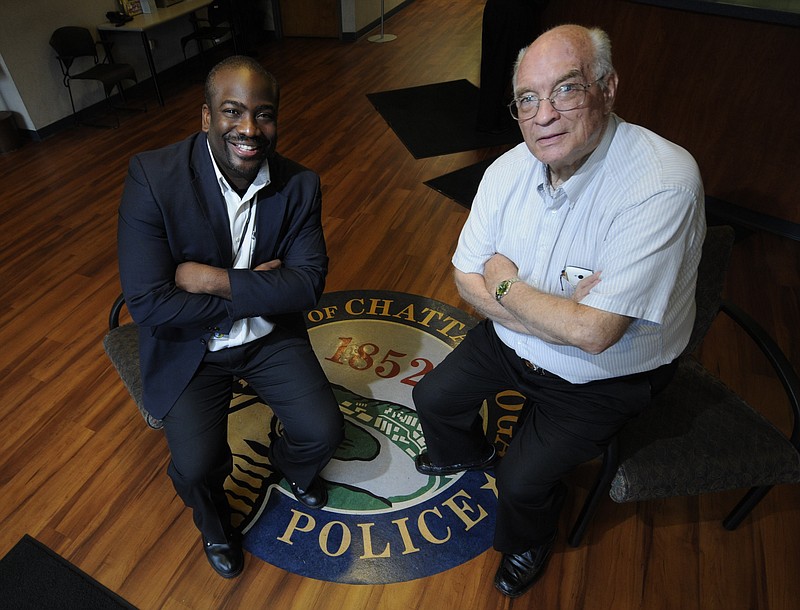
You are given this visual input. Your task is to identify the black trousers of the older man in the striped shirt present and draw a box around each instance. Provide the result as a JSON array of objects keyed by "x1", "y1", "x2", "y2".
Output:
[{"x1": 413, "y1": 320, "x2": 674, "y2": 553}]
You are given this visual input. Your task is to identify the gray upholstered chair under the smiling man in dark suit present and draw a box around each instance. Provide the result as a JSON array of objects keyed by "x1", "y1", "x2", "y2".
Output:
[{"x1": 103, "y1": 295, "x2": 164, "y2": 430}]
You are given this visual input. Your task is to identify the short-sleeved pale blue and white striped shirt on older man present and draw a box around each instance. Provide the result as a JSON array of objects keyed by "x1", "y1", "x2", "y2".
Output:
[{"x1": 453, "y1": 115, "x2": 705, "y2": 383}]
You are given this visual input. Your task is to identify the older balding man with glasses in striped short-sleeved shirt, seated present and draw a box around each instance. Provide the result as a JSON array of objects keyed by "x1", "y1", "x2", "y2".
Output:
[{"x1": 414, "y1": 25, "x2": 705, "y2": 597}]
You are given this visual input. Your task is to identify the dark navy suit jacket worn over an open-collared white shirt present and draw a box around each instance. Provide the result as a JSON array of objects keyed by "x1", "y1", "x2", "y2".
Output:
[{"x1": 118, "y1": 133, "x2": 328, "y2": 419}]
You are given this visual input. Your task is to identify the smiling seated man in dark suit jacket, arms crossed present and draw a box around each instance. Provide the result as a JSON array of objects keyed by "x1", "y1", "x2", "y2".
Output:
[{"x1": 118, "y1": 56, "x2": 343, "y2": 578}]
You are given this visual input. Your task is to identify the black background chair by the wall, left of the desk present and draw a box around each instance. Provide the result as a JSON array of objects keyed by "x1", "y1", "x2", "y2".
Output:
[{"x1": 50, "y1": 26, "x2": 145, "y2": 127}]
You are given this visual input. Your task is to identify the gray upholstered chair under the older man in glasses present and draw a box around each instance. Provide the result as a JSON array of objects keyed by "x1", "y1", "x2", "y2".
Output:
[{"x1": 568, "y1": 226, "x2": 800, "y2": 546}]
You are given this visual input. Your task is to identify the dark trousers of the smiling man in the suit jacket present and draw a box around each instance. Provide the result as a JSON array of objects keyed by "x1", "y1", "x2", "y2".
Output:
[{"x1": 164, "y1": 327, "x2": 344, "y2": 542}]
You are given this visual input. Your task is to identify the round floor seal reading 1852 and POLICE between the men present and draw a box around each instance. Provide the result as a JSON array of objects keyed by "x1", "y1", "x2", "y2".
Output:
[{"x1": 226, "y1": 291, "x2": 522, "y2": 584}]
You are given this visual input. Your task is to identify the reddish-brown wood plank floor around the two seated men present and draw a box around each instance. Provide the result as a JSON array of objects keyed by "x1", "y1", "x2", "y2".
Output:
[{"x1": 0, "y1": 0, "x2": 800, "y2": 610}]
